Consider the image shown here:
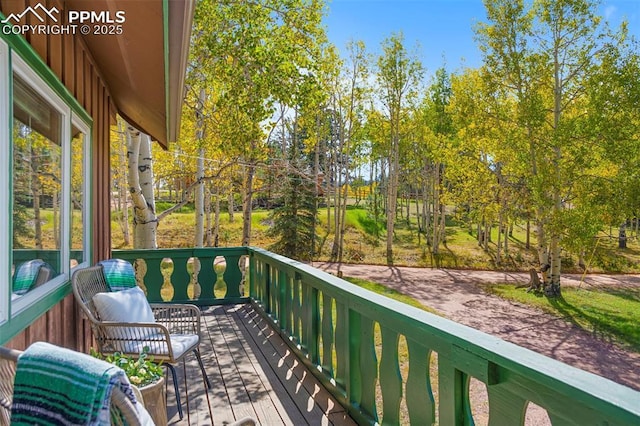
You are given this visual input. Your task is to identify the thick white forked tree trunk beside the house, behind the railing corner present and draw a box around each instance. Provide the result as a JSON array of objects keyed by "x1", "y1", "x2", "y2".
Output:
[{"x1": 127, "y1": 126, "x2": 158, "y2": 249}]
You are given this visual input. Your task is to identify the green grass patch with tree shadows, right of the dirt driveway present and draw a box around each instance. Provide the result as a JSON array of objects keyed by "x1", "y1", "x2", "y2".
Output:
[{"x1": 485, "y1": 284, "x2": 640, "y2": 352}]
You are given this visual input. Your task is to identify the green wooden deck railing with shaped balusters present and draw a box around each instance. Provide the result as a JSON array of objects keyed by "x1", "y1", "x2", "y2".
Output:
[{"x1": 114, "y1": 248, "x2": 640, "y2": 426}]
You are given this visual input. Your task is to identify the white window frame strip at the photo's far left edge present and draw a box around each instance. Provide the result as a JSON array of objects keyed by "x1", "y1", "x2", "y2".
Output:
[{"x1": 0, "y1": 39, "x2": 12, "y2": 324}]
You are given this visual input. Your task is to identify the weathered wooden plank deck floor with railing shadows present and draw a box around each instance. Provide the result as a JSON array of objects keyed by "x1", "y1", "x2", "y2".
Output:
[{"x1": 167, "y1": 305, "x2": 355, "y2": 426}]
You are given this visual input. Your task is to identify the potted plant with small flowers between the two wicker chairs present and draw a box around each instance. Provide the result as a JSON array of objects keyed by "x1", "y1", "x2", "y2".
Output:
[{"x1": 91, "y1": 346, "x2": 167, "y2": 426}]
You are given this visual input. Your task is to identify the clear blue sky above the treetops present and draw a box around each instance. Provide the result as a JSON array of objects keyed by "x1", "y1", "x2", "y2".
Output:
[{"x1": 324, "y1": 0, "x2": 640, "y2": 73}]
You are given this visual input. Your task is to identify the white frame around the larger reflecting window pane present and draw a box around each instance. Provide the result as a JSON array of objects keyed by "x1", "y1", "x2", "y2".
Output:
[{"x1": 10, "y1": 51, "x2": 72, "y2": 317}]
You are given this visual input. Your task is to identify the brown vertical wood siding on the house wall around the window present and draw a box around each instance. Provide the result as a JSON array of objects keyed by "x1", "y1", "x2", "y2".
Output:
[{"x1": 0, "y1": 0, "x2": 115, "y2": 352}]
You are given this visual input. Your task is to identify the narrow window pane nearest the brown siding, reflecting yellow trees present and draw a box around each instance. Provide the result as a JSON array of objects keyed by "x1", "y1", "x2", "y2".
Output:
[{"x1": 70, "y1": 126, "x2": 87, "y2": 268}]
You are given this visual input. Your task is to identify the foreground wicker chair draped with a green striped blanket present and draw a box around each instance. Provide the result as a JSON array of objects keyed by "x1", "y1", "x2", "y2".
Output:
[{"x1": 0, "y1": 347, "x2": 140, "y2": 426}]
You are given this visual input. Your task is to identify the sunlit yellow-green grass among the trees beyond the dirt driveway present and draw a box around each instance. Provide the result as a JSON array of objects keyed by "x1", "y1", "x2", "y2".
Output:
[{"x1": 111, "y1": 203, "x2": 640, "y2": 273}]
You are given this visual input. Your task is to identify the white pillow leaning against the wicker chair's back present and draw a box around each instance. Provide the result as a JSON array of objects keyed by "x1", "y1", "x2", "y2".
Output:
[{"x1": 93, "y1": 287, "x2": 157, "y2": 339}]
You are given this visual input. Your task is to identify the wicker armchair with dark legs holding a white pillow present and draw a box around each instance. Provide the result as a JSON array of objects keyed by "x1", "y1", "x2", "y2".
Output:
[{"x1": 71, "y1": 265, "x2": 211, "y2": 420}]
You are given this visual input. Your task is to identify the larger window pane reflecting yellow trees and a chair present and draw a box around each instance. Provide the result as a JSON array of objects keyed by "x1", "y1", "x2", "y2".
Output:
[{"x1": 12, "y1": 74, "x2": 62, "y2": 289}]
